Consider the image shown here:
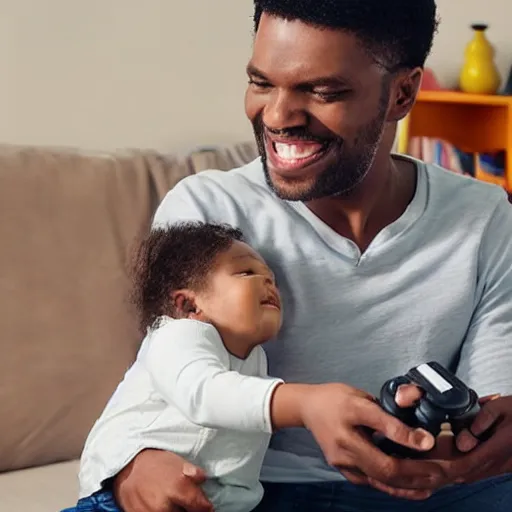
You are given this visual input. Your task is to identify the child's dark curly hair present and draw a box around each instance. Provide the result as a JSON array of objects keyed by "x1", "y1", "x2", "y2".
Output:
[{"x1": 132, "y1": 221, "x2": 243, "y2": 331}]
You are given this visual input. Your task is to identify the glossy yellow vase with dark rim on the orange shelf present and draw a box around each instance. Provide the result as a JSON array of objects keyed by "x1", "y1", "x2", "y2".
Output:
[{"x1": 459, "y1": 25, "x2": 501, "y2": 94}]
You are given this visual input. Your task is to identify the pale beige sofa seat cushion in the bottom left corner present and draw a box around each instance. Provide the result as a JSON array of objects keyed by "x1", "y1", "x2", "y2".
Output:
[{"x1": 0, "y1": 461, "x2": 78, "y2": 512}]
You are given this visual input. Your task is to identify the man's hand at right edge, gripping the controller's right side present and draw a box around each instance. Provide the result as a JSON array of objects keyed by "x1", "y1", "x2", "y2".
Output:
[{"x1": 447, "y1": 396, "x2": 512, "y2": 483}]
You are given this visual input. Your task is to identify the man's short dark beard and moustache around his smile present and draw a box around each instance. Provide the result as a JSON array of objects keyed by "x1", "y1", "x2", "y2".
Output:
[{"x1": 253, "y1": 101, "x2": 386, "y2": 202}]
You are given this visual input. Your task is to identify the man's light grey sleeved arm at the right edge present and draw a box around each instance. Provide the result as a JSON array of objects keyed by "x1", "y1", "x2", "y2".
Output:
[{"x1": 457, "y1": 193, "x2": 512, "y2": 396}]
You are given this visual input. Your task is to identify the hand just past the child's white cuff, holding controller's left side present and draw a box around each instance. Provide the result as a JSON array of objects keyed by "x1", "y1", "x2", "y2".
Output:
[{"x1": 294, "y1": 384, "x2": 450, "y2": 499}]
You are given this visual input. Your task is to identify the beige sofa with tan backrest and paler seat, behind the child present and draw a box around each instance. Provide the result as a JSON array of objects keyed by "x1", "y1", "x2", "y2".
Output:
[{"x1": 0, "y1": 143, "x2": 256, "y2": 512}]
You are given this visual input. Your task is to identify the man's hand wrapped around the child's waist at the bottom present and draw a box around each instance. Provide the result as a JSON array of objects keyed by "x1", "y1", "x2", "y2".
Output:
[{"x1": 114, "y1": 450, "x2": 213, "y2": 512}]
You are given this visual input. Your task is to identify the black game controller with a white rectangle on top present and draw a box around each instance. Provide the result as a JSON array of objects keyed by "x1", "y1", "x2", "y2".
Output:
[{"x1": 375, "y1": 361, "x2": 480, "y2": 458}]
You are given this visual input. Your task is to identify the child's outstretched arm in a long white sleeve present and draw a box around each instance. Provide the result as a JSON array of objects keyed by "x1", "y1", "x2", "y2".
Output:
[{"x1": 142, "y1": 320, "x2": 299, "y2": 432}]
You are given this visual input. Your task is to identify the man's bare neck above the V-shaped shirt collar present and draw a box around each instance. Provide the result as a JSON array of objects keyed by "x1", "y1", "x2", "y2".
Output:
[{"x1": 306, "y1": 156, "x2": 416, "y2": 252}]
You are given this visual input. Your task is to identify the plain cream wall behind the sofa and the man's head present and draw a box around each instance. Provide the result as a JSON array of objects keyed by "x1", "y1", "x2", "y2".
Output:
[{"x1": 0, "y1": 0, "x2": 512, "y2": 151}]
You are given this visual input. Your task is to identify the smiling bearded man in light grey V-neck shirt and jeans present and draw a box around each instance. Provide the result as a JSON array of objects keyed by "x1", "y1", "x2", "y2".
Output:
[{"x1": 113, "y1": 0, "x2": 512, "y2": 512}]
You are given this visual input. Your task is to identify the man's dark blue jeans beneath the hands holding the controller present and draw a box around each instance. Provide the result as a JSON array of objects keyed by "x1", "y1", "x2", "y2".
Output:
[{"x1": 254, "y1": 474, "x2": 512, "y2": 512}]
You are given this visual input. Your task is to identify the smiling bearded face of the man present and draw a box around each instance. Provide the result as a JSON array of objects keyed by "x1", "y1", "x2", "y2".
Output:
[{"x1": 245, "y1": 14, "x2": 389, "y2": 201}]
